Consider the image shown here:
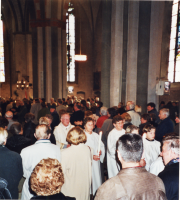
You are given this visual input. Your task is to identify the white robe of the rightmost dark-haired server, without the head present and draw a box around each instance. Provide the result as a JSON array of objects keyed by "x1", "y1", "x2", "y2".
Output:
[{"x1": 143, "y1": 138, "x2": 161, "y2": 171}]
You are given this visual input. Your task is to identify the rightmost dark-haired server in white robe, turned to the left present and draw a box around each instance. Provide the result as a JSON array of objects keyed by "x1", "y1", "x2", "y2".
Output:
[{"x1": 143, "y1": 125, "x2": 161, "y2": 171}]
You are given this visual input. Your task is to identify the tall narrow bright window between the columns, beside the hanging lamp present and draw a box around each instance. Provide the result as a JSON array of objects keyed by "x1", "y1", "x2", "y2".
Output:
[{"x1": 66, "y1": 2, "x2": 75, "y2": 82}]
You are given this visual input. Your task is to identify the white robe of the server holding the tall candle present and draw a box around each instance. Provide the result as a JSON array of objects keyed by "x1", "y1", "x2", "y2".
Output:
[{"x1": 85, "y1": 132, "x2": 105, "y2": 195}]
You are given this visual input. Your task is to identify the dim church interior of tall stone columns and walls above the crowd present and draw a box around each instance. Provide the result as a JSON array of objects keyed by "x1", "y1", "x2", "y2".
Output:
[{"x1": 0, "y1": 0, "x2": 180, "y2": 112}]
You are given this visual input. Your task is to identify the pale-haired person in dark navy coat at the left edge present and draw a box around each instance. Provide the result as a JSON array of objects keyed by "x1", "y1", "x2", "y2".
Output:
[{"x1": 0, "y1": 128, "x2": 23, "y2": 199}]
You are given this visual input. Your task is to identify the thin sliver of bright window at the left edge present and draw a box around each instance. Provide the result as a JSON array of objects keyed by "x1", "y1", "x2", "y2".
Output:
[{"x1": 0, "y1": 16, "x2": 5, "y2": 83}]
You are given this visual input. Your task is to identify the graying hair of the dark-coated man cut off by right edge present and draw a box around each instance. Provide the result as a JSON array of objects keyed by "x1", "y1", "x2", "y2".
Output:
[{"x1": 162, "y1": 135, "x2": 179, "y2": 156}]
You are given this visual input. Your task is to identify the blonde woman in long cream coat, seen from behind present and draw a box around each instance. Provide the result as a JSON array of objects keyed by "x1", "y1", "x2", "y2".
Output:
[{"x1": 61, "y1": 126, "x2": 92, "y2": 200}]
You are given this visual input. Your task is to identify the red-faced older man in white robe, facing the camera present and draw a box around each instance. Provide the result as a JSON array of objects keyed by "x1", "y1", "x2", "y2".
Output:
[{"x1": 53, "y1": 112, "x2": 74, "y2": 149}]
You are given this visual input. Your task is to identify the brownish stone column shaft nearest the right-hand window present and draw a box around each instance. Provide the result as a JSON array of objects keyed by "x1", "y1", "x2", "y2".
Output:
[{"x1": 147, "y1": 1, "x2": 164, "y2": 105}]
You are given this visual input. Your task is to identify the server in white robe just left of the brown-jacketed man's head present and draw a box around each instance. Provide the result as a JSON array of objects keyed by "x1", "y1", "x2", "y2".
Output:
[{"x1": 107, "y1": 115, "x2": 125, "y2": 178}]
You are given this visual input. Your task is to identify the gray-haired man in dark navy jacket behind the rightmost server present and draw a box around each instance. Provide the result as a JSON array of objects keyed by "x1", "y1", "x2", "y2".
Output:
[{"x1": 155, "y1": 108, "x2": 174, "y2": 142}]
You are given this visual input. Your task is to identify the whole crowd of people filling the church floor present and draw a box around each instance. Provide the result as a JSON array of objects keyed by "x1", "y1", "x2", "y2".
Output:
[{"x1": 0, "y1": 96, "x2": 180, "y2": 200}]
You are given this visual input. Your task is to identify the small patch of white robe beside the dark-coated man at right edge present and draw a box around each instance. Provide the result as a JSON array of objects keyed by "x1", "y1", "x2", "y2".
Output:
[{"x1": 149, "y1": 156, "x2": 165, "y2": 176}]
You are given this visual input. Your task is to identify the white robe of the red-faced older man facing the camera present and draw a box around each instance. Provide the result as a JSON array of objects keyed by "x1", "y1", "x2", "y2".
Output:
[{"x1": 53, "y1": 122, "x2": 74, "y2": 149}]
